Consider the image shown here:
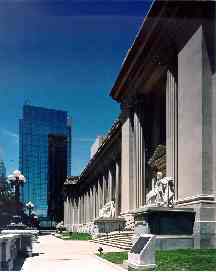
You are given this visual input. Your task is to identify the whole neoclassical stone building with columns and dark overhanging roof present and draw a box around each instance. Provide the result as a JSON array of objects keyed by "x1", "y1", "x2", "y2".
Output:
[{"x1": 65, "y1": 0, "x2": 216, "y2": 246}]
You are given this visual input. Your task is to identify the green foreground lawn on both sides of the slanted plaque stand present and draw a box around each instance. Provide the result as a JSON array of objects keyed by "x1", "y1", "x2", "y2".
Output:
[{"x1": 97, "y1": 249, "x2": 216, "y2": 271}]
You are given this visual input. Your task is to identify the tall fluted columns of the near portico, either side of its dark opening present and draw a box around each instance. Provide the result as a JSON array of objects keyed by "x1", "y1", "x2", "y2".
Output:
[{"x1": 121, "y1": 77, "x2": 178, "y2": 214}]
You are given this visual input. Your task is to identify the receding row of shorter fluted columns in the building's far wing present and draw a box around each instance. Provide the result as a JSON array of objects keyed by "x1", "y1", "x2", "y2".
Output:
[{"x1": 64, "y1": 162, "x2": 121, "y2": 230}]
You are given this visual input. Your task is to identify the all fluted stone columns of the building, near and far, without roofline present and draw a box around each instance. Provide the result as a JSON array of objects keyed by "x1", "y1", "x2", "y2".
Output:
[{"x1": 63, "y1": 70, "x2": 178, "y2": 223}]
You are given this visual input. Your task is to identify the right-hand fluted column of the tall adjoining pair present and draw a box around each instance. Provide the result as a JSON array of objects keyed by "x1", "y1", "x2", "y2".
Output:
[{"x1": 133, "y1": 97, "x2": 145, "y2": 208}]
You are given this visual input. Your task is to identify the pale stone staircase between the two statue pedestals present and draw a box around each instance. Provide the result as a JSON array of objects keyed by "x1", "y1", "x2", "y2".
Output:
[{"x1": 91, "y1": 231, "x2": 134, "y2": 250}]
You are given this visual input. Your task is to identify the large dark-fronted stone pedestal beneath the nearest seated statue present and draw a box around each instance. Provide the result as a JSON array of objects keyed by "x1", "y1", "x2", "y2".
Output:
[{"x1": 132, "y1": 207, "x2": 195, "y2": 250}]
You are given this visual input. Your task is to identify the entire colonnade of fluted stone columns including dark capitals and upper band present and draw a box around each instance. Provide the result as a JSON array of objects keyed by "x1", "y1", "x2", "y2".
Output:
[{"x1": 64, "y1": 78, "x2": 178, "y2": 228}]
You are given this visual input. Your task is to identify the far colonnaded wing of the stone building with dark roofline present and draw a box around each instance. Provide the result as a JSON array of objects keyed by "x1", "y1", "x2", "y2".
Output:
[{"x1": 64, "y1": 120, "x2": 121, "y2": 229}]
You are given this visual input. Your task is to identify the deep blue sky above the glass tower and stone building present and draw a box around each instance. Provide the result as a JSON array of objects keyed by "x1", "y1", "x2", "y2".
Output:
[{"x1": 0, "y1": 0, "x2": 150, "y2": 175}]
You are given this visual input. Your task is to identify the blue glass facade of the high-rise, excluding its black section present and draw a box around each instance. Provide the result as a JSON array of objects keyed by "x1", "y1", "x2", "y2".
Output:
[{"x1": 19, "y1": 105, "x2": 71, "y2": 218}]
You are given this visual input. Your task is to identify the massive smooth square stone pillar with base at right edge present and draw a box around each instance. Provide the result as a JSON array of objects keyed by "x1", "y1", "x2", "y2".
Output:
[{"x1": 178, "y1": 26, "x2": 216, "y2": 248}]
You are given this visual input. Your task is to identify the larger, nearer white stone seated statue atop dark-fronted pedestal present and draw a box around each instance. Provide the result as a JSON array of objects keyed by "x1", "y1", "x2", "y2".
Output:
[{"x1": 146, "y1": 172, "x2": 175, "y2": 207}]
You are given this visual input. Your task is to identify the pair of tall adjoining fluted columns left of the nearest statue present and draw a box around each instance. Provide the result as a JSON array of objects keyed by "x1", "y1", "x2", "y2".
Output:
[{"x1": 121, "y1": 98, "x2": 145, "y2": 214}]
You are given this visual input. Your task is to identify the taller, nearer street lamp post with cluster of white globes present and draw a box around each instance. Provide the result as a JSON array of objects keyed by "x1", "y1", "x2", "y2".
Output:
[{"x1": 8, "y1": 170, "x2": 25, "y2": 214}]
